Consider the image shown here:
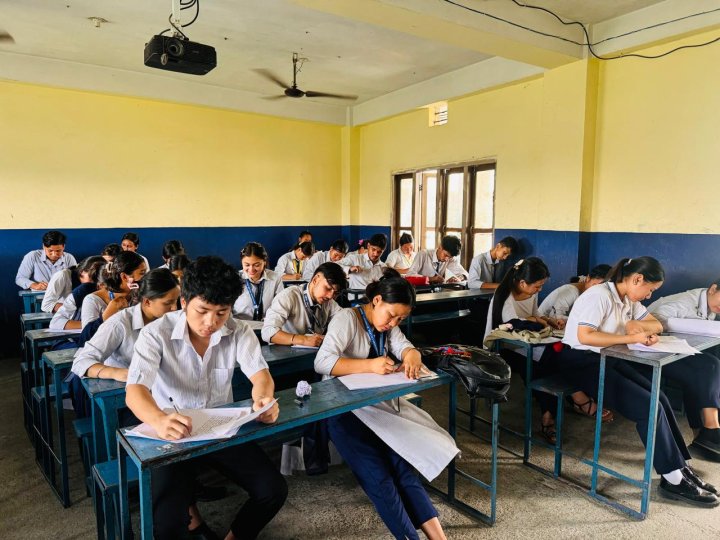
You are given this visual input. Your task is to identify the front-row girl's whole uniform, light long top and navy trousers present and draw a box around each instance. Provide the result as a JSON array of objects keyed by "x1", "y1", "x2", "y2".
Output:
[{"x1": 315, "y1": 308, "x2": 459, "y2": 539}]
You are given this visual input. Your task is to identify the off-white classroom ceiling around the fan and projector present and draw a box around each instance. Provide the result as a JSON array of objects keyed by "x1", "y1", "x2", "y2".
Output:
[{"x1": 0, "y1": 0, "x2": 708, "y2": 124}]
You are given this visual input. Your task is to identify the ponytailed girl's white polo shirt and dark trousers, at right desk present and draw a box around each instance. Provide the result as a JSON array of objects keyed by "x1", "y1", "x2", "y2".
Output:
[{"x1": 553, "y1": 282, "x2": 690, "y2": 474}]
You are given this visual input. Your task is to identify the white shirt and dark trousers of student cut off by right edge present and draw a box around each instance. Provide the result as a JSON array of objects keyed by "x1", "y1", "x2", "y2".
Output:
[{"x1": 638, "y1": 289, "x2": 720, "y2": 429}]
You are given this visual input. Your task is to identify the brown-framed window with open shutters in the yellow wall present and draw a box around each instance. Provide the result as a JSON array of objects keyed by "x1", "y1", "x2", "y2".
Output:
[{"x1": 392, "y1": 163, "x2": 495, "y2": 268}]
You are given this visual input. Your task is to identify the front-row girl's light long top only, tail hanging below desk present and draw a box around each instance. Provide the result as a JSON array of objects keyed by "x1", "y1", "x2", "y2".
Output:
[{"x1": 315, "y1": 308, "x2": 459, "y2": 480}]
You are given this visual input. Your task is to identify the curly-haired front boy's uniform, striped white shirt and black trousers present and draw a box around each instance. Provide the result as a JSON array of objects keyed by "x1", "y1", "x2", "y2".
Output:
[{"x1": 127, "y1": 311, "x2": 287, "y2": 539}]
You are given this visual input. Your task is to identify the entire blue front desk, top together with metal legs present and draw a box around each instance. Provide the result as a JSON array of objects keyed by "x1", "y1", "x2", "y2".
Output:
[{"x1": 117, "y1": 374, "x2": 496, "y2": 540}]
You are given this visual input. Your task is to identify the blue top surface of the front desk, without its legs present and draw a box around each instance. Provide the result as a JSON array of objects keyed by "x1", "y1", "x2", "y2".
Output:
[{"x1": 118, "y1": 373, "x2": 452, "y2": 466}]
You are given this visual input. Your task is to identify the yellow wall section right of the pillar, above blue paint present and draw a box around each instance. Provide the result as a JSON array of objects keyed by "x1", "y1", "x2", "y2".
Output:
[{"x1": 592, "y1": 31, "x2": 720, "y2": 234}]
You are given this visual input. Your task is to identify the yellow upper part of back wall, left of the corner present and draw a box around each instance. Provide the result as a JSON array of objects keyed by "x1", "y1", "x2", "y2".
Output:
[{"x1": 0, "y1": 82, "x2": 342, "y2": 229}]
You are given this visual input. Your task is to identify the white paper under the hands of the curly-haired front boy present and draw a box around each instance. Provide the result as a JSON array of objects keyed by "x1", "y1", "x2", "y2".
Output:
[{"x1": 125, "y1": 400, "x2": 277, "y2": 443}]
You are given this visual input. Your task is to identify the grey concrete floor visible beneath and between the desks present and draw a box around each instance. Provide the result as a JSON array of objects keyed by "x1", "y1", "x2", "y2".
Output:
[{"x1": 0, "y1": 354, "x2": 720, "y2": 540}]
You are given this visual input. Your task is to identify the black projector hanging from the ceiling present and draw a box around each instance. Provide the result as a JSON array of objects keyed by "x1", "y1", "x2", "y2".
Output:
[{"x1": 145, "y1": 35, "x2": 217, "y2": 75}]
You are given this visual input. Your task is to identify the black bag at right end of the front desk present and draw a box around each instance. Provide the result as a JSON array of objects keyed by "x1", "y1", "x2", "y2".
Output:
[{"x1": 420, "y1": 345, "x2": 510, "y2": 401}]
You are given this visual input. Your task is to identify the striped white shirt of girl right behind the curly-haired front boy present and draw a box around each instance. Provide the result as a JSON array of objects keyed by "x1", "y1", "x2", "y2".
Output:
[{"x1": 72, "y1": 304, "x2": 145, "y2": 377}]
